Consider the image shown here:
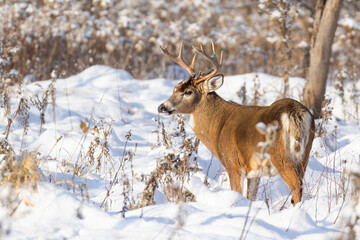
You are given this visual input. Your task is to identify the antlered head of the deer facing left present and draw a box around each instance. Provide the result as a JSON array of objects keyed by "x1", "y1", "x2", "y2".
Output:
[{"x1": 158, "y1": 43, "x2": 224, "y2": 115}]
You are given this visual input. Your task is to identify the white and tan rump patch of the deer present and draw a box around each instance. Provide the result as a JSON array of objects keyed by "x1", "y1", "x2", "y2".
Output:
[{"x1": 281, "y1": 111, "x2": 311, "y2": 161}]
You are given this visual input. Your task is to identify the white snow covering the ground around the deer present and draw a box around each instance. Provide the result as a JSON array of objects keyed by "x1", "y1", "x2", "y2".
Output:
[{"x1": 0, "y1": 66, "x2": 360, "y2": 239}]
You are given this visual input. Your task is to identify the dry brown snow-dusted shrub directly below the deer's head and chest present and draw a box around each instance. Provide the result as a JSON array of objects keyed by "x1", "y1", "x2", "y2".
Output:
[{"x1": 137, "y1": 115, "x2": 200, "y2": 207}]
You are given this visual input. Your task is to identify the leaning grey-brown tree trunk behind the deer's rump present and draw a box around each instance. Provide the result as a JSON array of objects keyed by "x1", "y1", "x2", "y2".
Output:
[{"x1": 303, "y1": 0, "x2": 343, "y2": 118}]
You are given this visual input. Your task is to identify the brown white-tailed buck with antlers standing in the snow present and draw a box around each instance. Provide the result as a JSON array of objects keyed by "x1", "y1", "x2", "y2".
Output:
[{"x1": 158, "y1": 44, "x2": 315, "y2": 205}]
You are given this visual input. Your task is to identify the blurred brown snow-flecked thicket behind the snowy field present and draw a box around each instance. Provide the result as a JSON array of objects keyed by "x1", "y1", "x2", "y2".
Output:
[{"x1": 0, "y1": 0, "x2": 360, "y2": 115}]
